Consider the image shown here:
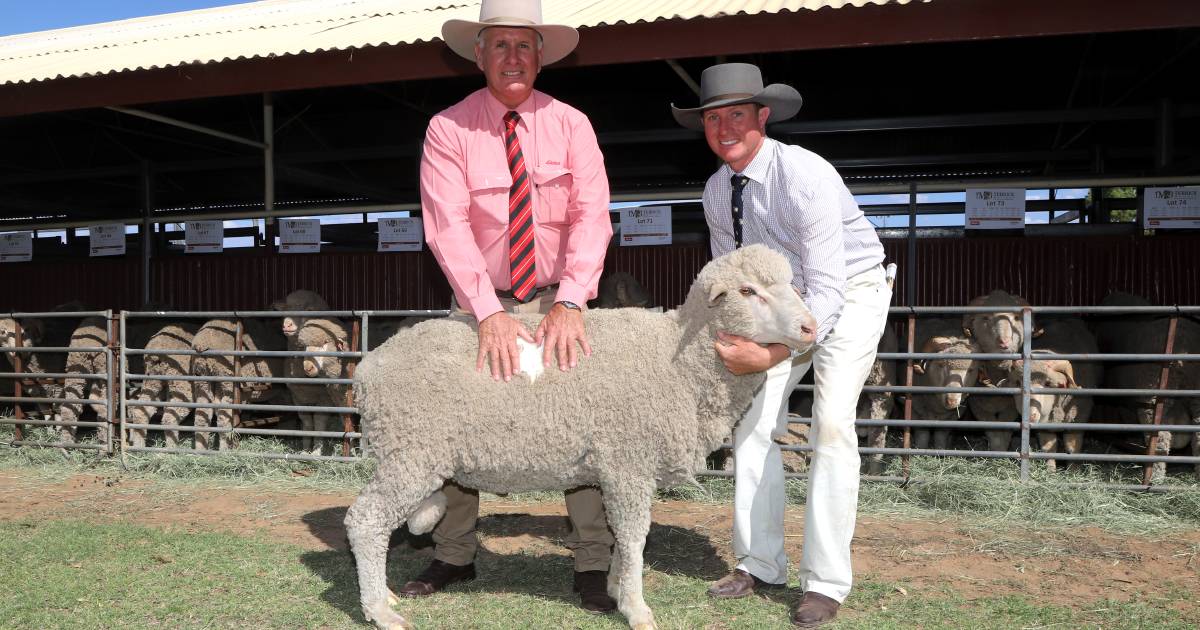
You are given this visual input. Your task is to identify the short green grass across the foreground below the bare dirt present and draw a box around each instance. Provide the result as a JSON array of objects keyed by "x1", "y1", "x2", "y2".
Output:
[{"x1": 0, "y1": 521, "x2": 1200, "y2": 630}]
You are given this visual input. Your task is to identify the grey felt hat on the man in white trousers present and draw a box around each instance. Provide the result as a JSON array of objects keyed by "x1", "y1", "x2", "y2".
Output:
[{"x1": 671, "y1": 64, "x2": 804, "y2": 131}]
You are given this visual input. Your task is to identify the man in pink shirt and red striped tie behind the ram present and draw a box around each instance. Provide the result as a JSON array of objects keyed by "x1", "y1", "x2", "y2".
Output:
[{"x1": 401, "y1": 0, "x2": 616, "y2": 612}]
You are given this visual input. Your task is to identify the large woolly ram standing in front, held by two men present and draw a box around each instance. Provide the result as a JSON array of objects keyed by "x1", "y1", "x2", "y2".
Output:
[{"x1": 346, "y1": 245, "x2": 815, "y2": 630}]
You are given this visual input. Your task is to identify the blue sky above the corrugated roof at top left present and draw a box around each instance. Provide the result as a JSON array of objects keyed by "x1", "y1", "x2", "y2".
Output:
[{"x1": 0, "y1": 0, "x2": 246, "y2": 37}]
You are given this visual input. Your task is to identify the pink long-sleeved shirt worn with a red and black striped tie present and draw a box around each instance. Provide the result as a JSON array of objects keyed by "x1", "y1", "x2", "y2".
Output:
[{"x1": 421, "y1": 88, "x2": 612, "y2": 322}]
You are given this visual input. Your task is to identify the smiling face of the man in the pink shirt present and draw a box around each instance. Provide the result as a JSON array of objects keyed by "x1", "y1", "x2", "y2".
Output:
[{"x1": 475, "y1": 26, "x2": 541, "y2": 109}]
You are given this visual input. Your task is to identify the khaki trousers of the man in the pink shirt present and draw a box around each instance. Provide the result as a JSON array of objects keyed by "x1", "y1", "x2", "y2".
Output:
[{"x1": 433, "y1": 290, "x2": 613, "y2": 571}]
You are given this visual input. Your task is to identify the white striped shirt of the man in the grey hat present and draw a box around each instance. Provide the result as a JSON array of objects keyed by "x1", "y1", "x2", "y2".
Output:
[{"x1": 704, "y1": 138, "x2": 883, "y2": 342}]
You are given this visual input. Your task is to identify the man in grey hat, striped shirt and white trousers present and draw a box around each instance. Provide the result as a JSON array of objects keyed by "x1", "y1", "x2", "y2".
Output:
[{"x1": 672, "y1": 64, "x2": 892, "y2": 628}]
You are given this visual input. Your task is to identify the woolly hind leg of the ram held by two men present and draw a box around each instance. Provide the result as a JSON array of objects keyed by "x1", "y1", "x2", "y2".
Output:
[{"x1": 346, "y1": 467, "x2": 443, "y2": 630}]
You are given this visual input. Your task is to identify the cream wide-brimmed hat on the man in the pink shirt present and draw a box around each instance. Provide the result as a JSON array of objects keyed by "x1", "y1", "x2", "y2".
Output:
[{"x1": 442, "y1": 0, "x2": 580, "y2": 66}]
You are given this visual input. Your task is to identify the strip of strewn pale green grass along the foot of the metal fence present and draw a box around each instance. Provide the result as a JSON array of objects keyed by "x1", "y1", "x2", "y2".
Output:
[{"x1": 7, "y1": 426, "x2": 1200, "y2": 534}]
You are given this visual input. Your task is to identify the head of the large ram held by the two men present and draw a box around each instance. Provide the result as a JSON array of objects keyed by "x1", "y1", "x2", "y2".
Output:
[{"x1": 689, "y1": 245, "x2": 817, "y2": 353}]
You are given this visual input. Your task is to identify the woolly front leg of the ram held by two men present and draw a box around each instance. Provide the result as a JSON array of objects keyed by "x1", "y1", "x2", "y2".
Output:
[{"x1": 600, "y1": 477, "x2": 658, "y2": 630}]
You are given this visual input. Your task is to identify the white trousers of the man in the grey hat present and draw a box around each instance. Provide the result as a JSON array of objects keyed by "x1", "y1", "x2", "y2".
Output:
[{"x1": 733, "y1": 266, "x2": 892, "y2": 602}]
